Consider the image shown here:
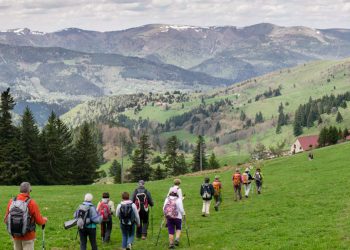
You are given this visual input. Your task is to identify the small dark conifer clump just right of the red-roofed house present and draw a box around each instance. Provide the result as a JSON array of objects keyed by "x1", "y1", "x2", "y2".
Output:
[{"x1": 318, "y1": 126, "x2": 350, "y2": 147}]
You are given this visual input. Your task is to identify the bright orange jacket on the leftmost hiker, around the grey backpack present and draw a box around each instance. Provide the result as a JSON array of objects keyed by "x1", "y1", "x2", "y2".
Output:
[{"x1": 5, "y1": 193, "x2": 46, "y2": 240}]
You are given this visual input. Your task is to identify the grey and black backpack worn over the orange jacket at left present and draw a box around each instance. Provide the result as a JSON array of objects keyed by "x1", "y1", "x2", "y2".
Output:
[{"x1": 6, "y1": 198, "x2": 35, "y2": 237}]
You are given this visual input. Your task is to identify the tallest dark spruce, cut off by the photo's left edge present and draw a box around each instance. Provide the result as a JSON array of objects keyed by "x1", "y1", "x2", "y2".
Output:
[{"x1": 0, "y1": 88, "x2": 30, "y2": 185}]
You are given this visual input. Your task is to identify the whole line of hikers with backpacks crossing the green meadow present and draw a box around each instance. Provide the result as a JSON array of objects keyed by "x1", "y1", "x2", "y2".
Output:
[{"x1": 5, "y1": 168, "x2": 263, "y2": 250}]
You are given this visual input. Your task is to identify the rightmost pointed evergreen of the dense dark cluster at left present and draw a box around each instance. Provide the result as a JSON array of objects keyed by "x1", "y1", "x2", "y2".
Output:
[{"x1": 72, "y1": 122, "x2": 98, "y2": 184}]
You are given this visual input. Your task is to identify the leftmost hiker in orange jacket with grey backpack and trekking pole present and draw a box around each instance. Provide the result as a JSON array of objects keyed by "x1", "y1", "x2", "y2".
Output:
[{"x1": 4, "y1": 182, "x2": 47, "y2": 250}]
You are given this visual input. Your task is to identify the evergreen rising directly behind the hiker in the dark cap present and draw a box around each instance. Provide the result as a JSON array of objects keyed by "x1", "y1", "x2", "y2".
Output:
[{"x1": 130, "y1": 134, "x2": 152, "y2": 182}]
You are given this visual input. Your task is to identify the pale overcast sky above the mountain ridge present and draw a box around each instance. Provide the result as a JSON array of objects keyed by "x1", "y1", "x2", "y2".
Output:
[{"x1": 0, "y1": 0, "x2": 350, "y2": 32}]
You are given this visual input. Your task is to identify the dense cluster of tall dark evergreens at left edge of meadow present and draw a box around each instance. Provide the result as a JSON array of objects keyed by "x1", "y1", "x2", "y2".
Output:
[{"x1": 0, "y1": 89, "x2": 99, "y2": 185}]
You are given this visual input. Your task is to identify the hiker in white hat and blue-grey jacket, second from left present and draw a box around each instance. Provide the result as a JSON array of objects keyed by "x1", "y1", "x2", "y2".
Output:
[{"x1": 74, "y1": 193, "x2": 102, "y2": 250}]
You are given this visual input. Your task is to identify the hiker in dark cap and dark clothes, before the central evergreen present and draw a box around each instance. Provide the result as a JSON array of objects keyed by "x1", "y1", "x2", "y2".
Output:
[{"x1": 132, "y1": 180, "x2": 153, "y2": 240}]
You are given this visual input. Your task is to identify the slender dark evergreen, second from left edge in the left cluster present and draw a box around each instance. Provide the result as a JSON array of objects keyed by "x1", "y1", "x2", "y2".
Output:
[{"x1": 20, "y1": 107, "x2": 42, "y2": 184}]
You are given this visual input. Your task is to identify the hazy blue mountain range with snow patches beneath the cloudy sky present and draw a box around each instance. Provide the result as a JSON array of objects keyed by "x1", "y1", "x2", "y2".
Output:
[{"x1": 0, "y1": 23, "x2": 350, "y2": 122}]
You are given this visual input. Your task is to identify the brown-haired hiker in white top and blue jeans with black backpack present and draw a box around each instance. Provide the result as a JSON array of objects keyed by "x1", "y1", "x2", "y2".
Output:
[{"x1": 116, "y1": 192, "x2": 140, "y2": 250}]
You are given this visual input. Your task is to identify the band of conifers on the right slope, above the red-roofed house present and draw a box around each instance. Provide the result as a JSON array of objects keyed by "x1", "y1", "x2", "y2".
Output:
[{"x1": 293, "y1": 91, "x2": 350, "y2": 136}]
